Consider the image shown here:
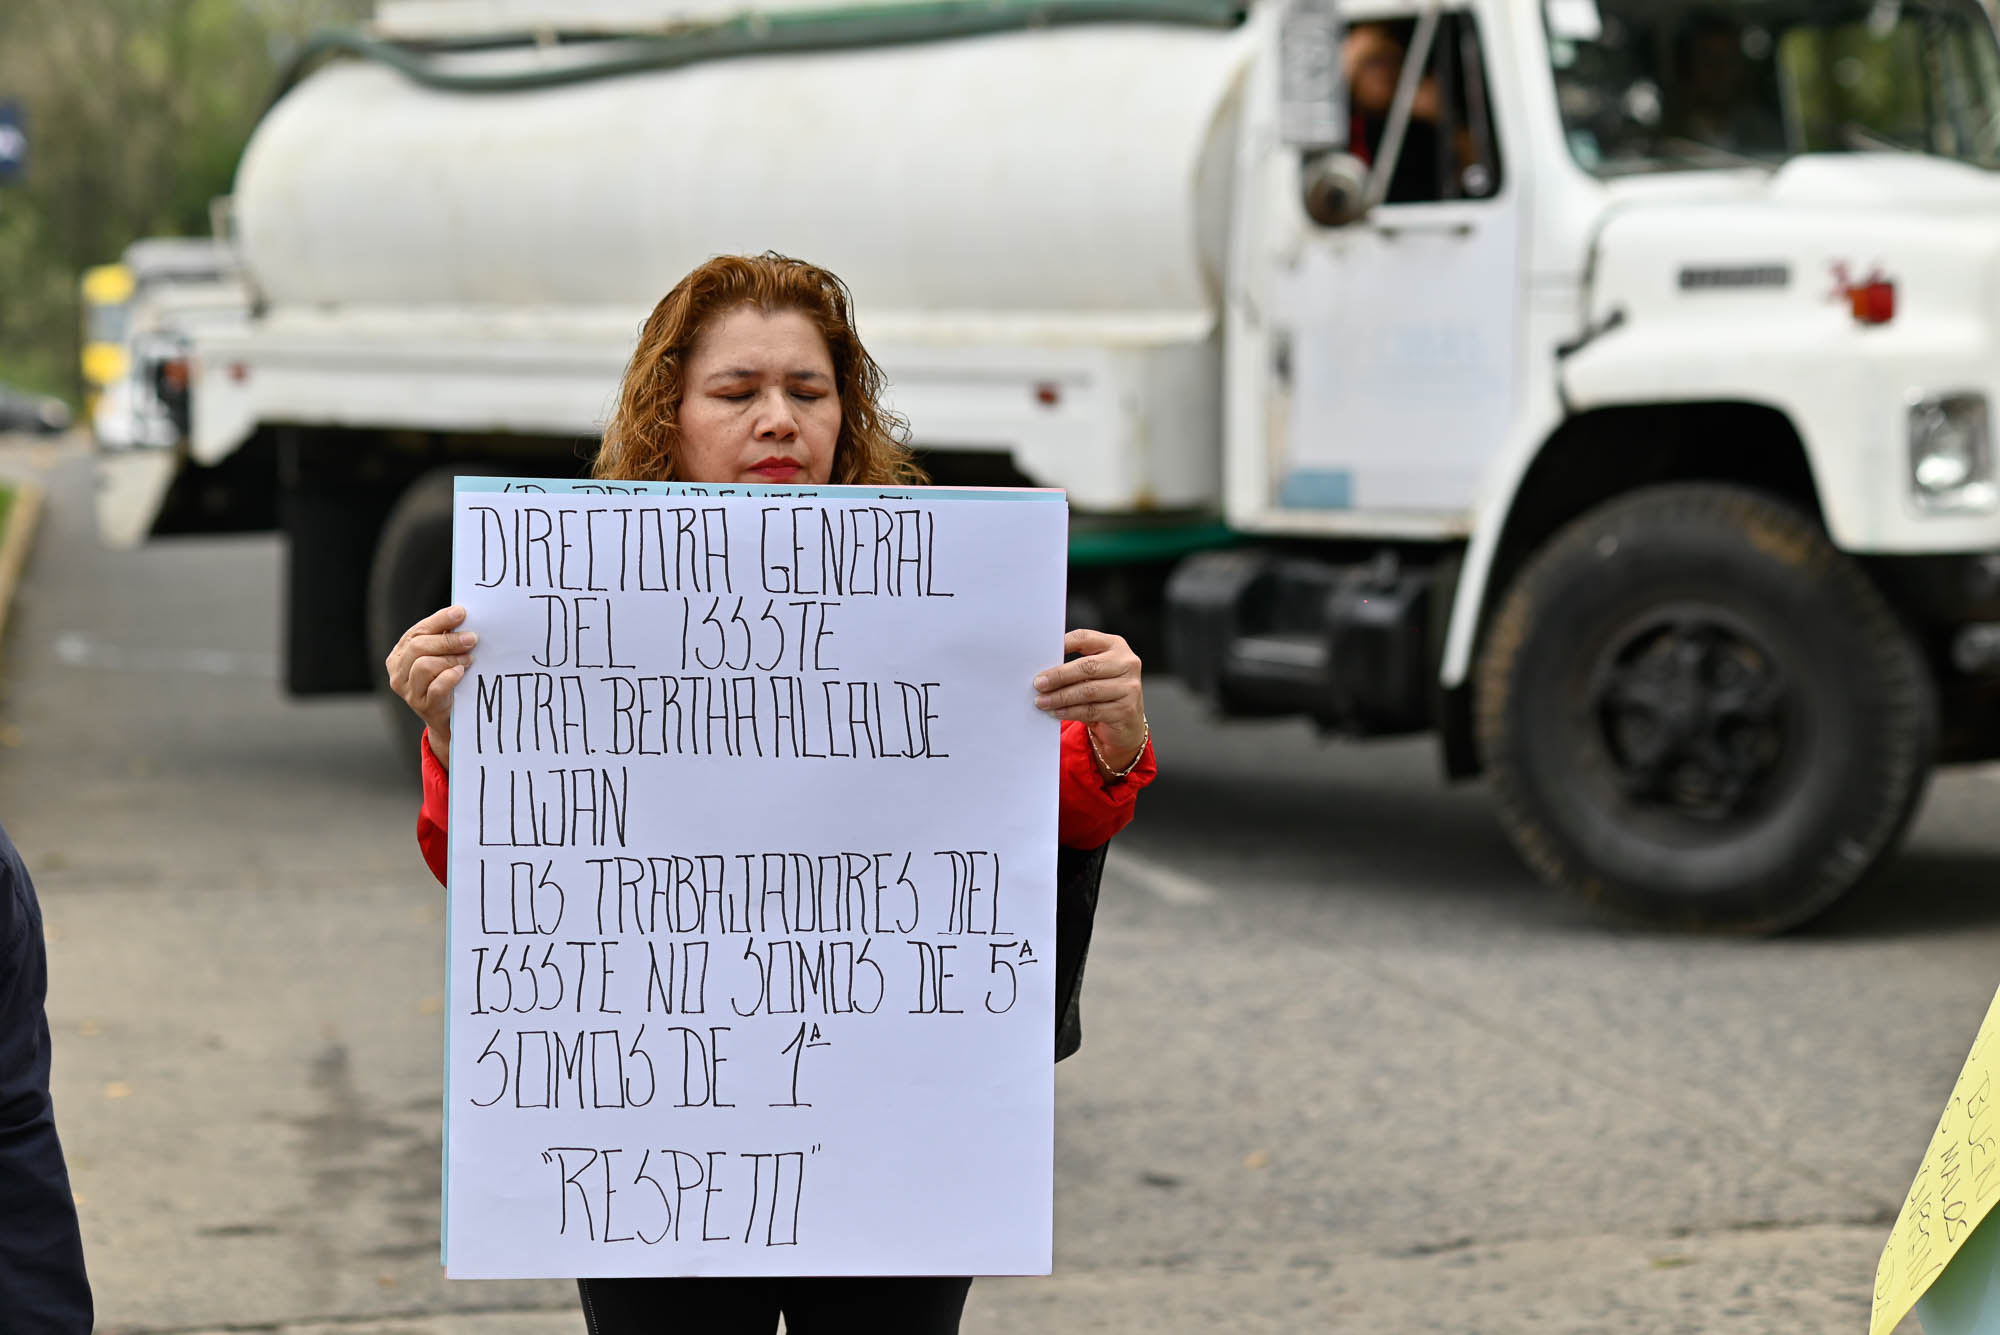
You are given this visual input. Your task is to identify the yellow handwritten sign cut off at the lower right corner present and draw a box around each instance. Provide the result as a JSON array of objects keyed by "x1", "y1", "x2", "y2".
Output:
[{"x1": 1868, "y1": 995, "x2": 2000, "y2": 1335}]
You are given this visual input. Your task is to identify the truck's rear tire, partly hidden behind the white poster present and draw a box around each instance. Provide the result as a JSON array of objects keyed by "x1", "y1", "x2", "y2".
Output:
[{"x1": 368, "y1": 468, "x2": 458, "y2": 773}]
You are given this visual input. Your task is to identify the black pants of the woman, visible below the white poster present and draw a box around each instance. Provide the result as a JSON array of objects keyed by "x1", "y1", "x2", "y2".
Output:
[{"x1": 576, "y1": 1275, "x2": 972, "y2": 1335}]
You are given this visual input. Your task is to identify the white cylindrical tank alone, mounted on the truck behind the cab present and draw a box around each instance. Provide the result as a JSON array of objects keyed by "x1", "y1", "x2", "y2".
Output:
[{"x1": 234, "y1": 24, "x2": 1248, "y2": 329}]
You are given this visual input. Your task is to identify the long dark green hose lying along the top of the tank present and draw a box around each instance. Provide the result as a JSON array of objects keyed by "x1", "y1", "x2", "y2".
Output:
[{"x1": 272, "y1": 0, "x2": 1246, "y2": 102}]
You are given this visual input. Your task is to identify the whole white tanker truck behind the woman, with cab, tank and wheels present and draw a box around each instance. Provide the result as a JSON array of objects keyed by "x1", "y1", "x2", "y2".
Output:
[{"x1": 102, "y1": 0, "x2": 2000, "y2": 931}]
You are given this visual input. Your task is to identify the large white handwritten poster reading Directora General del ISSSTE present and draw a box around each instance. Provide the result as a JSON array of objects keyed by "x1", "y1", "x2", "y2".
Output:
[{"x1": 444, "y1": 478, "x2": 1068, "y2": 1279}]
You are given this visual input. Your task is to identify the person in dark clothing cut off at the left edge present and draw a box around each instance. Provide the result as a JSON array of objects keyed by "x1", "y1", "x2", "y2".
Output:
[{"x1": 0, "y1": 829, "x2": 92, "y2": 1335}]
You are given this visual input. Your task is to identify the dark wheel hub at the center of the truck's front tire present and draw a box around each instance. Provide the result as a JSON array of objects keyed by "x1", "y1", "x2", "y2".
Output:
[{"x1": 1590, "y1": 614, "x2": 1790, "y2": 821}]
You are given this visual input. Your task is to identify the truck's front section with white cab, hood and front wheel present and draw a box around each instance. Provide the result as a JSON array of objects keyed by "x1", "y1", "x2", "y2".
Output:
[{"x1": 1168, "y1": 0, "x2": 2000, "y2": 929}]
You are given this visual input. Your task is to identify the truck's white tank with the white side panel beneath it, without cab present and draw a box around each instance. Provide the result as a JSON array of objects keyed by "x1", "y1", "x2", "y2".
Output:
[{"x1": 194, "y1": 28, "x2": 1254, "y2": 510}]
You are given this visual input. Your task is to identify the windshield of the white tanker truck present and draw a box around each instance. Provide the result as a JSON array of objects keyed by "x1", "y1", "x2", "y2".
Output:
[{"x1": 1544, "y1": 0, "x2": 2000, "y2": 176}]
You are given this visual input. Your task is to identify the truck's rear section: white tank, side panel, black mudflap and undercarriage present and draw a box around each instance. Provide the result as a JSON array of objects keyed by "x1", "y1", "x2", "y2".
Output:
[{"x1": 188, "y1": 0, "x2": 1268, "y2": 739}]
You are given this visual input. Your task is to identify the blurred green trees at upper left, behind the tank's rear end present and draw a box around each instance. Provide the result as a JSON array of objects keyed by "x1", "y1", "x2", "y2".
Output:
[{"x1": 0, "y1": 0, "x2": 372, "y2": 398}]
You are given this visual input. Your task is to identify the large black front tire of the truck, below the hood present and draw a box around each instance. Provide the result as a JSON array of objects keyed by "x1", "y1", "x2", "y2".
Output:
[{"x1": 1474, "y1": 484, "x2": 1936, "y2": 933}]
